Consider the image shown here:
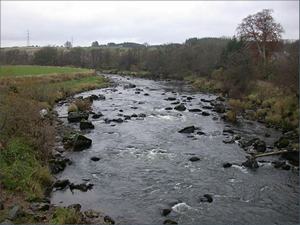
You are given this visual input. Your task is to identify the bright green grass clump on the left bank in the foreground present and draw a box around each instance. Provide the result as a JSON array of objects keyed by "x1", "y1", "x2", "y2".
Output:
[{"x1": 0, "y1": 138, "x2": 52, "y2": 199}]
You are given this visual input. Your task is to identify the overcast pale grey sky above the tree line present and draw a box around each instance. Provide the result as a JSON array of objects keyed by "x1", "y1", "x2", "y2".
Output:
[{"x1": 1, "y1": 1, "x2": 299, "y2": 47}]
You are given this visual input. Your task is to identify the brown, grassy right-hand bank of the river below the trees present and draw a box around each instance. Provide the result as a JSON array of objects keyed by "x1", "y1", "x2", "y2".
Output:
[{"x1": 102, "y1": 69, "x2": 300, "y2": 135}]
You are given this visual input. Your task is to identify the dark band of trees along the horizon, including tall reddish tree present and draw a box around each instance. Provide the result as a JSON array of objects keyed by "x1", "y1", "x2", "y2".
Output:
[{"x1": 0, "y1": 9, "x2": 299, "y2": 96}]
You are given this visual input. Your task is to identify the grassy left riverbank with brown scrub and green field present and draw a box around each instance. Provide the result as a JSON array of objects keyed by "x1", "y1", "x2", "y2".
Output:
[{"x1": 0, "y1": 66, "x2": 109, "y2": 223}]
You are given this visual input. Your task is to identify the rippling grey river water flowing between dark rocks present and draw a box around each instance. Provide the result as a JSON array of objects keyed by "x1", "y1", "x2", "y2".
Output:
[{"x1": 52, "y1": 75, "x2": 299, "y2": 224}]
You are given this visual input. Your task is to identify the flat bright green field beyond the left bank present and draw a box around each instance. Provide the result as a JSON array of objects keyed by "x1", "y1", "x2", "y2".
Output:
[{"x1": 0, "y1": 65, "x2": 92, "y2": 78}]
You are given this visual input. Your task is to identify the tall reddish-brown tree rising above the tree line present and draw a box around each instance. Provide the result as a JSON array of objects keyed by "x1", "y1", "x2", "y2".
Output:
[{"x1": 237, "y1": 9, "x2": 283, "y2": 65}]
